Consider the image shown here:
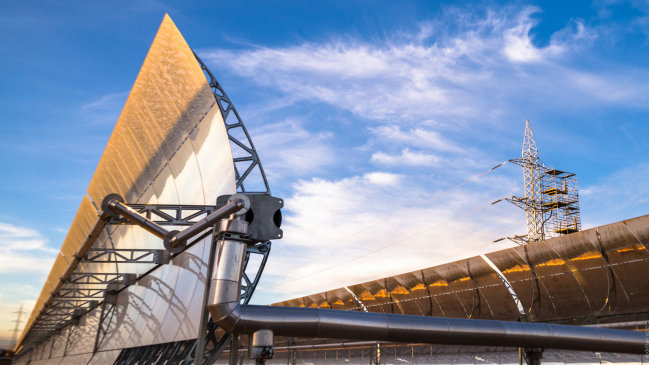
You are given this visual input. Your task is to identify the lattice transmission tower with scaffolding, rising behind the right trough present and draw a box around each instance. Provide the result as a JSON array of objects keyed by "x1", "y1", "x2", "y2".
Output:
[{"x1": 506, "y1": 120, "x2": 581, "y2": 244}]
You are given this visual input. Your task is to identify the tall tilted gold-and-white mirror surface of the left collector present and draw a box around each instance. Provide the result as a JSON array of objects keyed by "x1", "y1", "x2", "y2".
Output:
[{"x1": 19, "y1": 16, "x2": 236, "y2": 363}]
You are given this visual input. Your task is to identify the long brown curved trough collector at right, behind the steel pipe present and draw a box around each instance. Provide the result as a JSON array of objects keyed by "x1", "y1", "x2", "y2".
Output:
[{"x1": 274, "y1": 215, "x2": 649, "y2": 324}]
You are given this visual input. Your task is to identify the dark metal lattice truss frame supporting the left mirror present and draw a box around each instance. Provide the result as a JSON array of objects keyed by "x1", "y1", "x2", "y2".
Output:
[{"x1": 19, "y1": 53, "x2": 272, "y2": 364}]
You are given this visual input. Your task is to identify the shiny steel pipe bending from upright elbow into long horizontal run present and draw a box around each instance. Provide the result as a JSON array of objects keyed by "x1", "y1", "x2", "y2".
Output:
[{"x1": 209, "y1": 240, "x2": 647, "y2": 354}]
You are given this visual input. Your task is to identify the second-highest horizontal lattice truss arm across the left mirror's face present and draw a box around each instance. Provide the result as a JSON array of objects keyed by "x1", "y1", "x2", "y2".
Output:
[{"x1": 81, "y1": 248, "x2": 169, "y2": 265}]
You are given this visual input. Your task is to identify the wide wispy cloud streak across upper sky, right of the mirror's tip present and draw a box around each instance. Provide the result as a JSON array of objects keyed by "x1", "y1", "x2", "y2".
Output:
[{"x1": 202, "y1": 7, "x2": 649, "y2": 124}]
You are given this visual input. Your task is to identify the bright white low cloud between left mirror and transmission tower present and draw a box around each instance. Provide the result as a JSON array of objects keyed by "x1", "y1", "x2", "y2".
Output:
[{"x1": 255, "y1": 172, "x2": 523, "y2": 302}]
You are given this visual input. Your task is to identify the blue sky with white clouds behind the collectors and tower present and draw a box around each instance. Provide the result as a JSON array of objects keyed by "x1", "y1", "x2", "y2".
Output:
[{"x1": 0, "y1": 1, "x2": 649, "y2": 346}]
